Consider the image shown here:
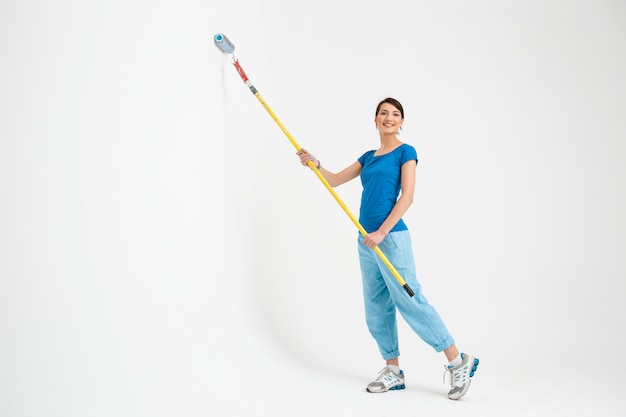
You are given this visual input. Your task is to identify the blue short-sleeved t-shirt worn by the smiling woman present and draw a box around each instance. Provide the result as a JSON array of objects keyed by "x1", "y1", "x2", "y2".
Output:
[{"x1": 358, "y1": 143, "x2": 417, "y2": 233}]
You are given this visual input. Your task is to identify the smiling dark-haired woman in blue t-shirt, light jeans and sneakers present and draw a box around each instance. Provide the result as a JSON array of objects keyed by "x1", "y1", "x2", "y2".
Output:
[{"x1": 297, "y1": 98, "x2": 478, "y2": 400}]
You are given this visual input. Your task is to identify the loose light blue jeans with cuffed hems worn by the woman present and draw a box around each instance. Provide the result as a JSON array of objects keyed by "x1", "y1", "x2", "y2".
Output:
[{"x1": 358, "y1": 230, "x2": 454, "y2": 360}]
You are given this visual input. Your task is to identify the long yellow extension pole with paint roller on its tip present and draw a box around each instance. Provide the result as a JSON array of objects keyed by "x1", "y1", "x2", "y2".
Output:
[{"x1": 215, "y1": 33, "x2": 415, "y2": 297}]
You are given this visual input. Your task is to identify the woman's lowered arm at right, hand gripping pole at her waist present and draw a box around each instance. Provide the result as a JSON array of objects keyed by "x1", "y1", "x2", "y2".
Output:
[{"x1": 363, "y1": 160, "x2": 417, "y2": 249}]
